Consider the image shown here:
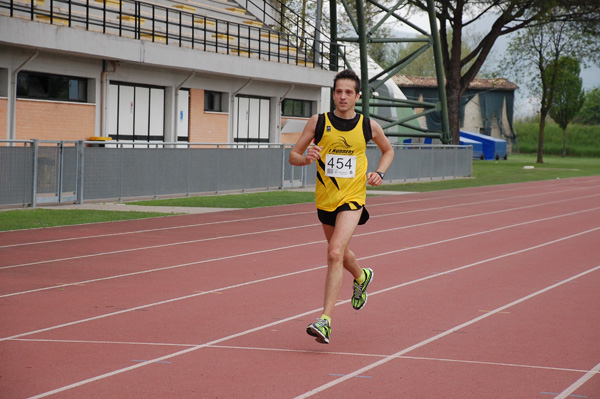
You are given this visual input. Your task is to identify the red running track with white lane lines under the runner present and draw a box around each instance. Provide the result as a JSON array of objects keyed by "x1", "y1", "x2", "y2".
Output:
[{"x1": 0, "y1": 177, "x2": 600, "y2": 399}]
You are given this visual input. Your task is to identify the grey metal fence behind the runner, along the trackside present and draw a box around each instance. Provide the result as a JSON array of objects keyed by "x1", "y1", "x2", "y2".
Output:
[{"x1": 0, "y1": 140, "x2": 473, "y2": 207}]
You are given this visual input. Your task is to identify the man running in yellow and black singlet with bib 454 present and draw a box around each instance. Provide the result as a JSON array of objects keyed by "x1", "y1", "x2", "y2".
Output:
[{"x1": 289, "y1": 70, "x2": 394, "y2": 344}]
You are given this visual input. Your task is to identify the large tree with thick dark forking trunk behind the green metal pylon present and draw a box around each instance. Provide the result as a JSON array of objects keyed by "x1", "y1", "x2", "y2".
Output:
[{"x1": 407, "y1": 0, "x2": 600, "y2": 144}]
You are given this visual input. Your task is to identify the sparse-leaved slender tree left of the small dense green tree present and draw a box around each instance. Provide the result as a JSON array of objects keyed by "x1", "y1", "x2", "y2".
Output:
[{"x1": 504, "y1": 15, "x2": 600, "y2": 163}]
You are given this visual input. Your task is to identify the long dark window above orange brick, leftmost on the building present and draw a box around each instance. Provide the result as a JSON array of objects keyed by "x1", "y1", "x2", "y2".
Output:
[{"x1": 17, "y1": 72, "x2": 87, "y2": 102}]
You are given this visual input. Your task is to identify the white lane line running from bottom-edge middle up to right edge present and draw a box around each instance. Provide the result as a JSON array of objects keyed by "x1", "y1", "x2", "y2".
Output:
[{"x1": 294, "y1": 265, "x2": 600, "y2": 399}]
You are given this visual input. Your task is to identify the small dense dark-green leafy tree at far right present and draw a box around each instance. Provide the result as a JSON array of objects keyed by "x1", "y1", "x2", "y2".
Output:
[{"x1": 547, "y1": 57, "x2": 584, "y2": 157}]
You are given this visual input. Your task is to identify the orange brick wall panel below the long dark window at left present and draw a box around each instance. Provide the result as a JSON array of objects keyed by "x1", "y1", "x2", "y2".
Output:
[{"x1": 16, "y1": 99, "x2": 96, "y2": 140}]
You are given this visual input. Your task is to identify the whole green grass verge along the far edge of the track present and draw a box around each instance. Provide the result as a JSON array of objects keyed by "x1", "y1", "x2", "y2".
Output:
[{"x1": 0, "y1": 154, "x2": 600, "y2": 231}]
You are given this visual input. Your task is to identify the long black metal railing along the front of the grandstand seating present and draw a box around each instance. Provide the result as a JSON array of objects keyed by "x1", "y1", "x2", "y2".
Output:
[{"x1": 0, "y1": 0, "x2": 343, "y2": 69}]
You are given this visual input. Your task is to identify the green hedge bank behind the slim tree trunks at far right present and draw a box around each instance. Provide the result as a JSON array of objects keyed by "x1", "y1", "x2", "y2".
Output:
[{"x1": 514, "y1": 122, "x2": 600, "y2": 157}]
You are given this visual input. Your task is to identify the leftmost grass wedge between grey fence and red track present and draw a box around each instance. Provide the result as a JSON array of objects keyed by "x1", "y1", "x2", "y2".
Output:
[{"x1": 0, "y1": 208, "x2": 165, "y2": 231}]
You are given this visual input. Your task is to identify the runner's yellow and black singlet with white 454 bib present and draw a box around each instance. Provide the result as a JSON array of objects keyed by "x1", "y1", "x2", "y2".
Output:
[{"x1": 315, "y1": 112, "x2": 372, "y2": 212}]
